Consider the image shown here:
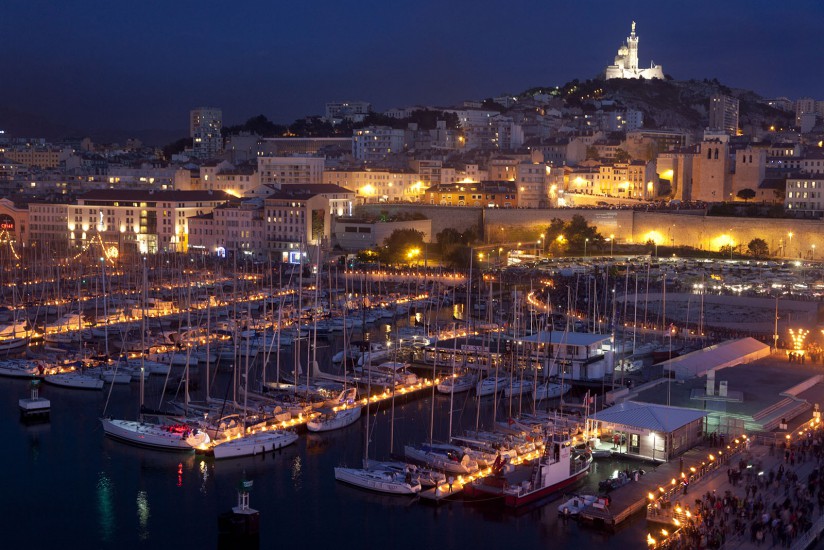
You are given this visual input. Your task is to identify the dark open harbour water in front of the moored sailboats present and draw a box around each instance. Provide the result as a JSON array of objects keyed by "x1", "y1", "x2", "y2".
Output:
[{"x1": 0, "y1": 352, "x2": 645, "y2": 550}]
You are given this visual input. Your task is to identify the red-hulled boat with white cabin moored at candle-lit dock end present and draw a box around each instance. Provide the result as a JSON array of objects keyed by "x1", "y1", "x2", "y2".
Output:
[{"x1": 464, "y1": 434, "x2": 592, "y2": 508}]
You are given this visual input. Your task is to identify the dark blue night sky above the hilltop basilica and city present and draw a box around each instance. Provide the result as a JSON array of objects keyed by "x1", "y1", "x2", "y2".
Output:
[{"x1": 0, "y1": 0, "x2": 824, "y2": 138}]
